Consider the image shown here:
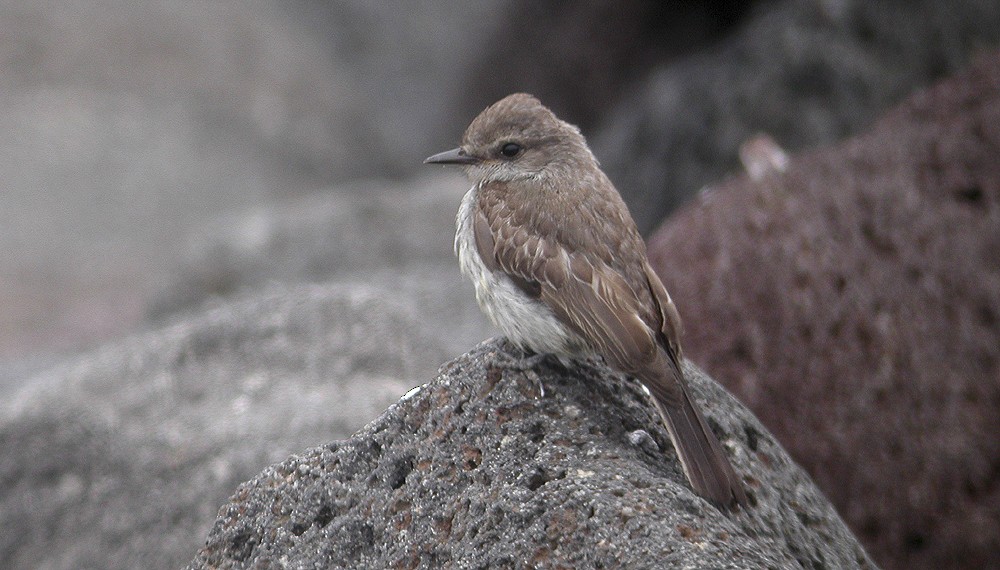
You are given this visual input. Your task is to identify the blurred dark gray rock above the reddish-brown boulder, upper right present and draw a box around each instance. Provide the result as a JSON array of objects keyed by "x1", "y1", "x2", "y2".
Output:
[{"x1": 591, "y1": 0, "x2": 1000, "y2": 233}]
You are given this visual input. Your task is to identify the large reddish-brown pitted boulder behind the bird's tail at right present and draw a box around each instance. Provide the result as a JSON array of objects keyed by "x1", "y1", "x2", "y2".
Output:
[{"x1": 650, "y1": 54, "x2": 1000, "y2": 569}]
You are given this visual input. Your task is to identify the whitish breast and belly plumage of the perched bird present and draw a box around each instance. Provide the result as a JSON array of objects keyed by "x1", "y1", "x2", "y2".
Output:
[{"x1": 455, "y1": 186, "x2": 588, "y2": 356}]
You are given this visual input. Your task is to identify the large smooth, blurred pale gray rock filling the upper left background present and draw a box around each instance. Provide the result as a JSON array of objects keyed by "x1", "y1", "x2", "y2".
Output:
[{"x1": 0, "y1": 0, "x2": 503, "y2": 359}]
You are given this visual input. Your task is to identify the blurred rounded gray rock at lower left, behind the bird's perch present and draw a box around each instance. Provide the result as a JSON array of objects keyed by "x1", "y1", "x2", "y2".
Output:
[{"x1": 0, "y1": 284, "x2": 447, "y2": 569}]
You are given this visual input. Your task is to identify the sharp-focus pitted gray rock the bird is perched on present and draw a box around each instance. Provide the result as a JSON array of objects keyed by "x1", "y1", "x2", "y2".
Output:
[{"x1": 188, "y1": 341, "x2": 875, "y2": 570}]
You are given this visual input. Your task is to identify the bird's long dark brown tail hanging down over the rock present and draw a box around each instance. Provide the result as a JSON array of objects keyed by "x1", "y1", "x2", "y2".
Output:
[{"x1": 650, "y1": 366, "x2": 747, "y2": 509}]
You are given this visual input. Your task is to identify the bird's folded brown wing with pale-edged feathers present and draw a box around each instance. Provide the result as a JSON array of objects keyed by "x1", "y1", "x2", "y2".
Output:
[{"x1": 474, "y1": 180, "x2": 672, "y2": 373}]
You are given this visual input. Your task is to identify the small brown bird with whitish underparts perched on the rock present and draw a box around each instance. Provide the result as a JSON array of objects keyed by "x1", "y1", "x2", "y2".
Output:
[{"x1": 424, "y1": 93, "x2": 747, "y2": 508}]
